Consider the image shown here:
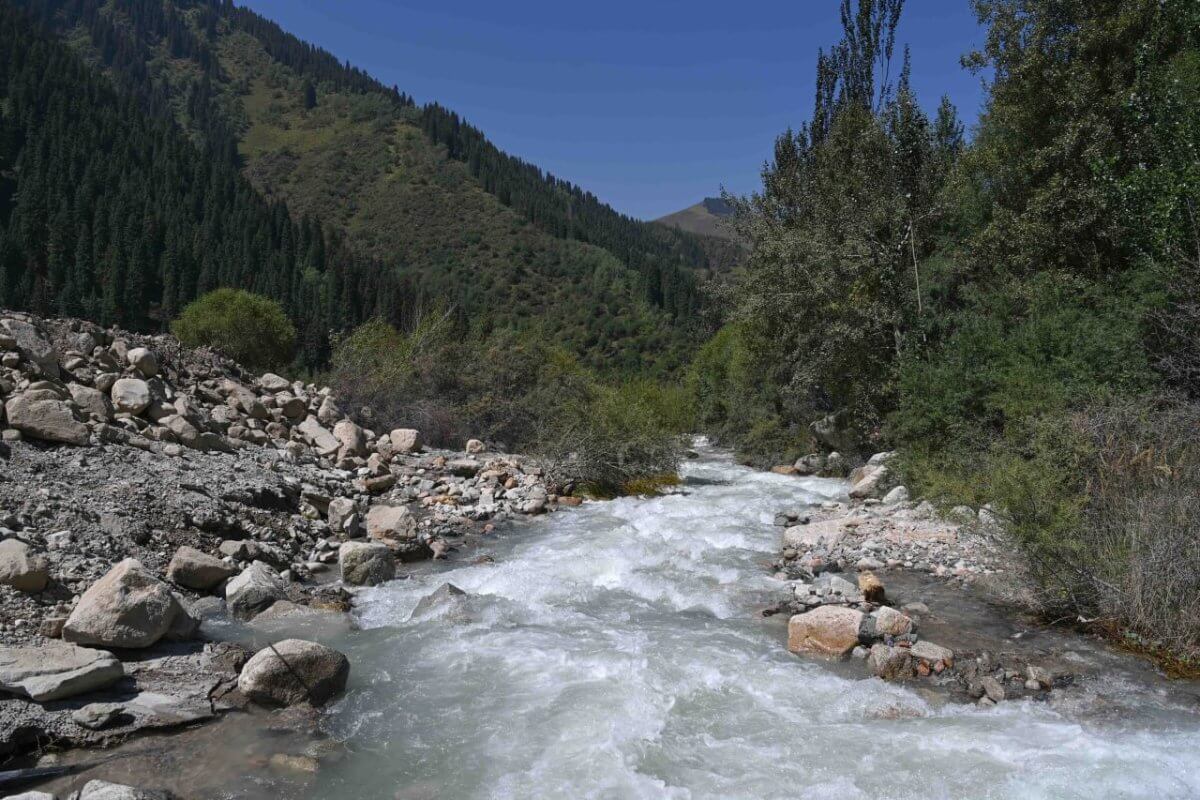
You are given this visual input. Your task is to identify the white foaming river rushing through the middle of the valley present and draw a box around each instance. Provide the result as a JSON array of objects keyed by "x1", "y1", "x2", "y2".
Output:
[{"x1": 300, "y1": 453, "x2": 1200, "y2": 800}]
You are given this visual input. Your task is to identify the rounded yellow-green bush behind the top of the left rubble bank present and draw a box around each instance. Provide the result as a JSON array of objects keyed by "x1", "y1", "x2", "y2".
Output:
[{"x1": 170, "y1": 289, "x2": 296, "y2": 369}]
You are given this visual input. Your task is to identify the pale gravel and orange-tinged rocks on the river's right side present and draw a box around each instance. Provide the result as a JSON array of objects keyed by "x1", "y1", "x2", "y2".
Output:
[{"x1": 766, "y1": 452, "x2": 1072, "y2": 705}]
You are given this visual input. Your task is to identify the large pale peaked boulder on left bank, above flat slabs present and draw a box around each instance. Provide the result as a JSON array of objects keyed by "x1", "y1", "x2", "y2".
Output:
[{"x1": 62, "y1": 559, "x2": 196, "y2": 648}]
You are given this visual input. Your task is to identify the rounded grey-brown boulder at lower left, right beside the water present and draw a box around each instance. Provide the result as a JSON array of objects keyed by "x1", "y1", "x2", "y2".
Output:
[{"x1": 238, "y1": 639, "x2": 350, "y2": 705}]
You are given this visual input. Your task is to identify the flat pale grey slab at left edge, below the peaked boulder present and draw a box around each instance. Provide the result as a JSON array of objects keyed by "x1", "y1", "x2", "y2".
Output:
[{"x1": 0, "y1": 642, "x2": 125, "y2": 703}]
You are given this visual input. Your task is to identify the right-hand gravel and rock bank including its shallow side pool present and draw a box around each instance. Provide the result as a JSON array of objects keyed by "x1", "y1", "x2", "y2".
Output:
[{"x1": 764, "y1": 453, "x2": 1196, "y2": 708}]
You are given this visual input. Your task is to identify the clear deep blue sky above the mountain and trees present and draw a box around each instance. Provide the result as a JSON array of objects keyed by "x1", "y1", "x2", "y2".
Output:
[{"x1": 238, "y1": 0, "x2": 983, "y2": 218}]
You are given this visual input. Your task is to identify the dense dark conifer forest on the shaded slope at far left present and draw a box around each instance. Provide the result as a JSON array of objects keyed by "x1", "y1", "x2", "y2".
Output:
[{"x1": 0, "y1": 5, "x2": 415, "y2": 362}]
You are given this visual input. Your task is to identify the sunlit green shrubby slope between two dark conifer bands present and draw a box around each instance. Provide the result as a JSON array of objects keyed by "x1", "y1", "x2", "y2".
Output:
[{"x1": 208, "y1": 32, "x2": 684, "y2": 369}]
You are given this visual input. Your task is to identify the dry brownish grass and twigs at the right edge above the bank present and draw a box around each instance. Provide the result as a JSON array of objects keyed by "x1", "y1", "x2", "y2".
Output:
[{"x1": 1034, "y1": 398, "x2": 1200, "y2": 657}]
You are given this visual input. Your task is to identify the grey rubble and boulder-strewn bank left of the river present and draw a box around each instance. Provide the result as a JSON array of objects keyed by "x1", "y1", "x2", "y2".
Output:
[{"x1": 0, "y1": 312, "x2": 577, "y2": 796}]
